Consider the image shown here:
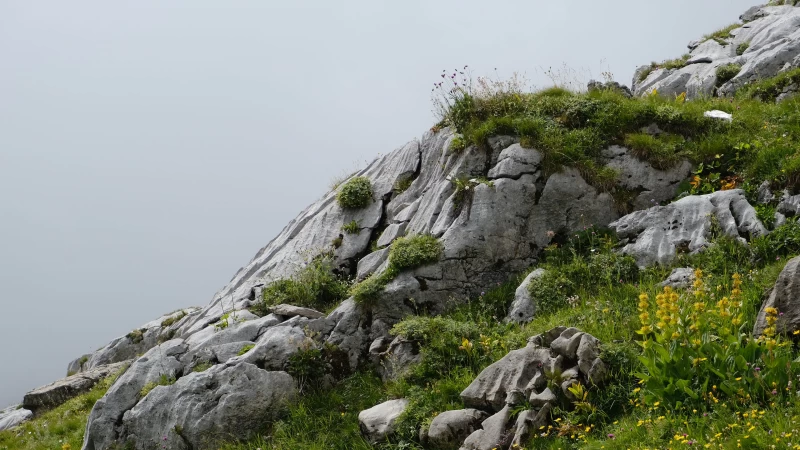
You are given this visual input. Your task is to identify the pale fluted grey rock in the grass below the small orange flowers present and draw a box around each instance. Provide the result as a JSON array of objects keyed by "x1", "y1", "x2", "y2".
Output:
[{"x1": 610, "y1": 189, "x2": 767, "y2": 266}]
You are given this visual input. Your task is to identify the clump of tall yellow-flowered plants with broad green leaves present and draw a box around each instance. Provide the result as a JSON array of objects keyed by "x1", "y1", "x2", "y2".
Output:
[{"x1": 637, "y1": 270, "x2": 800, "y2": 409}]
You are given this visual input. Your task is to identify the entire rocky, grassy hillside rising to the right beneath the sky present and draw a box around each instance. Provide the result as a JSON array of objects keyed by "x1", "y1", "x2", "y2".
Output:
[{"x1": 7, "y1": 4, "x2": 800, "y2": 450}]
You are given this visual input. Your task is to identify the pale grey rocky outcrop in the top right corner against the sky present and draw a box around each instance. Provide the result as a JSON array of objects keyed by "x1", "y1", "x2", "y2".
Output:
[{"x1": 633, "y1": 5, "x2": 800, "y2": 98}]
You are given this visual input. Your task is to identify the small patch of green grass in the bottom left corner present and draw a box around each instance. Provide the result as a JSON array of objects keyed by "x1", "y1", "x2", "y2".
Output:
[{"x1": 0, "y1": 369, "x2": 124, "y2": 450}]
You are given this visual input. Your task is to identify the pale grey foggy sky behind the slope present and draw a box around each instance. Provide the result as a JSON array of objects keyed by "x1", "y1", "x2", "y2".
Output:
[{"x1": 0, "y1": 0, "x2": 754, "y2": 407}]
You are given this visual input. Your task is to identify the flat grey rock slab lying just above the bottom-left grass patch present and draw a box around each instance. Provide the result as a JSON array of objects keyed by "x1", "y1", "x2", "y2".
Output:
[{"x1": 22, "y1": 361, "x2": 130, "y2": 414}]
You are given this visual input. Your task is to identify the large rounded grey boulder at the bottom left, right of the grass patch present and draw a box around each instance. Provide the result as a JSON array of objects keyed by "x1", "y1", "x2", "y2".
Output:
[{"x1": 119, "y1": 363, "x2": 297, "y2": 450}]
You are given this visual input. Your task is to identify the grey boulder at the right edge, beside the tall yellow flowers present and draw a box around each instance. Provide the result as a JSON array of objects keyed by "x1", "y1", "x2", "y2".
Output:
[{"x1": 753, "y1": 257, "x2": 800, "y2": 336}]
